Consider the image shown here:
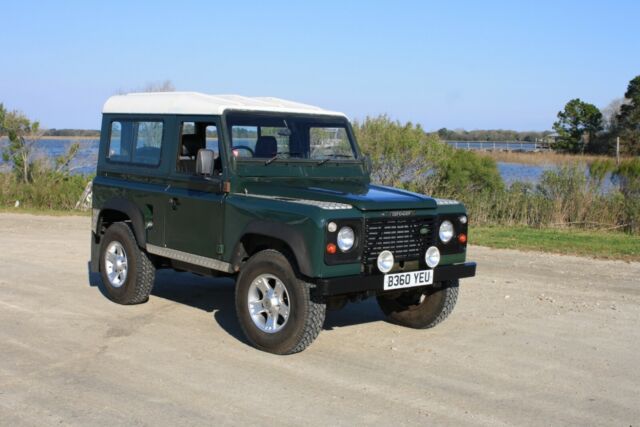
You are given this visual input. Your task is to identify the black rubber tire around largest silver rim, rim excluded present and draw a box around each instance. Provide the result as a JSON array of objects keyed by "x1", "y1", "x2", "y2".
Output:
[{"x1": 235, "y1": 249, "x2": 326, "y2": 354}]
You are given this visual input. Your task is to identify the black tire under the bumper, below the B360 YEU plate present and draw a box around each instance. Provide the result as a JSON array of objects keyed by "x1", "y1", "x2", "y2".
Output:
[{"x1": 377, "y1": 280, "x2": 459, "y2": 329}]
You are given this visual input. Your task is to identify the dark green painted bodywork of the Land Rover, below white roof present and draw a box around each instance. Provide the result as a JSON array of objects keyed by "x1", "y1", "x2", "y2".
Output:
[{"x1": 93, "y1": 110, "x2": 466, "y2": 278}]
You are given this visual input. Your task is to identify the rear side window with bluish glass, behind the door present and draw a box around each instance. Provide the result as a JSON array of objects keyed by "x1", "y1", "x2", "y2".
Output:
[{"x1": 107, "y1": 120, "x2": 163, "y2": 166}]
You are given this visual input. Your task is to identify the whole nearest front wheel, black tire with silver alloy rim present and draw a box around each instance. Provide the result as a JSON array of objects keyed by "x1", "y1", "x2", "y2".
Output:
[{"x1": 236, "y1": 250, "x2": 326, "y2": 354}]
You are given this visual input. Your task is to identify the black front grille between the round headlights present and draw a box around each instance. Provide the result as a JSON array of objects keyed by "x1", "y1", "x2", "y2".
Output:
[{"x1": 362, "y1": 216, "x2": 436, "y2": 265}]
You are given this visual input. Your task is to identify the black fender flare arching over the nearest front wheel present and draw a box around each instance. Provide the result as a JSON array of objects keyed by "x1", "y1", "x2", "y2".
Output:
[{"x1": 231, "y1": 221, "x2": 313, "y2": 277}]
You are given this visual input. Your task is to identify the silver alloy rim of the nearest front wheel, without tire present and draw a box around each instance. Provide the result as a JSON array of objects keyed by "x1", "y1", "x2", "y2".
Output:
[{"x1": 247, "y1": 274, "x2": 289, "y2": 334}]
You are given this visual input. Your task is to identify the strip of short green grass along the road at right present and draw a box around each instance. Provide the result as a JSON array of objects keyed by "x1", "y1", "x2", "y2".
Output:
[{"x1": 470, "y1": 226, "x2": 640, "y2": 261}]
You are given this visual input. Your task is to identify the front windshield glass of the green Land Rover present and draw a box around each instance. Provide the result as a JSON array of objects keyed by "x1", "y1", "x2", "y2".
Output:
[{"x1": 227, "y1": 114, "x2": 356, "y2": 162}]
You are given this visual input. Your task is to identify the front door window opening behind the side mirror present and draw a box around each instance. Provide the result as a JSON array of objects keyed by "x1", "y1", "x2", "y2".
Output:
[{"x1": 176, "y1": 122, "x2": 222, "y2": 175}]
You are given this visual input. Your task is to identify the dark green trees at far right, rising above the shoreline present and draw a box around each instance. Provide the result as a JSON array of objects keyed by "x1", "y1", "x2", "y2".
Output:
[{"x1": 553, "y1": 75, "x2": 640, "y2": 156}]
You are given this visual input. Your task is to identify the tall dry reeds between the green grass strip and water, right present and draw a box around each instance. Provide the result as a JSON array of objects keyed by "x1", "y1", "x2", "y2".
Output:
[{"x1": 423, "y1": 161, "x2": 640, "y2": 233}]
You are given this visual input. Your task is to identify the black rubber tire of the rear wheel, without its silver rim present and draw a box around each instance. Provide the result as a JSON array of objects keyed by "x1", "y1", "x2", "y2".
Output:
[{"x1": 100, "y1": 222, "x2": 156, "y2": 305}]
